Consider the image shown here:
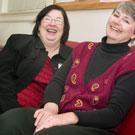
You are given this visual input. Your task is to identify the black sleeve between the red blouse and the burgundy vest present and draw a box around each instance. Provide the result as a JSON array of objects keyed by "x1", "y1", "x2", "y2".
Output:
[{"x1": 43, "y1": 55, "x2": 72, "y2": 104}]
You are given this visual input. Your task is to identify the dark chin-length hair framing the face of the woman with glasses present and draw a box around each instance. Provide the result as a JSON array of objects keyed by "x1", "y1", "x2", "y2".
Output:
[{"x1": 32, "y1": 5, "x2": 70, "y2": 44}]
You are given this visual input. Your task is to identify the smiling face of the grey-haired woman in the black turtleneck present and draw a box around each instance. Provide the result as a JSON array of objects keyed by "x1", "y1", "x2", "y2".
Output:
[{"x1": 106, "y1": 9, "x2": 135, "y2": 43}]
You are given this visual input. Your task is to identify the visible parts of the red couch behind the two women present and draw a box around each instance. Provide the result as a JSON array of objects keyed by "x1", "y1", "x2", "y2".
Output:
[{"x1": 66, "y1": 41, "x2": 135, "y2": 135}]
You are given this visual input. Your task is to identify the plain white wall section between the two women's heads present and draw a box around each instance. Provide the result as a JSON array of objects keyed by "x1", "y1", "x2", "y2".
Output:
[{"x1": 68, "y1": 10, "x2": 112, "y2": 41}]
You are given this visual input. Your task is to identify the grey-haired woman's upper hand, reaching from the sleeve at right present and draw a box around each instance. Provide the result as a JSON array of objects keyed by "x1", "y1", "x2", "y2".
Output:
[{"x1": 35, "y1": 112, "x2": 78, "y2": 132}]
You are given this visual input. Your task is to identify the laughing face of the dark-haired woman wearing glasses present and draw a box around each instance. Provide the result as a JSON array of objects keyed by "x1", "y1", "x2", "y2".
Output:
[{"x1": 39, "y1": 9, "x2": 64, "y2": 43}]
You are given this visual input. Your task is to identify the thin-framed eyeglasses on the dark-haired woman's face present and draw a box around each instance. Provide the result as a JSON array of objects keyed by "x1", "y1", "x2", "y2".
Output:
[{"x1": 43, "y1": 16, "x2": 64, "y2": 25}]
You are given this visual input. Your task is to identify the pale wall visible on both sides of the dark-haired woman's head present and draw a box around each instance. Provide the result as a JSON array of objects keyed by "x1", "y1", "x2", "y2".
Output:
[{"x1": 0, "y1": 9, "x2": 112, "y2": 45}]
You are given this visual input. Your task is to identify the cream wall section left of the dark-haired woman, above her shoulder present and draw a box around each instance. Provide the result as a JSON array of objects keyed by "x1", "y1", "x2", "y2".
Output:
[{"x1": 0, "y1": 13, "x2": 37, "y2": 46}]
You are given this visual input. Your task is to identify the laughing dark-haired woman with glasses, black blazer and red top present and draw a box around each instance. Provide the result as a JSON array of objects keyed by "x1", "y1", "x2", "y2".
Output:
[{"x1": 0, "y1": 5, "x2": 71, "y2": 113}]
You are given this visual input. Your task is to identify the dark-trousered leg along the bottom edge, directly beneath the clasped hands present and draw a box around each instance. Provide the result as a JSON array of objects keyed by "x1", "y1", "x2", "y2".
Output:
[{"x1": 35, "y1": 125, "x2": 114, "y2": 135}]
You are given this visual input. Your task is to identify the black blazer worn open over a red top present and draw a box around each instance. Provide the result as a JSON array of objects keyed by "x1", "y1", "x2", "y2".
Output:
[{"x1": 0, "y1": 34, "x2": 72, "y2": 113}]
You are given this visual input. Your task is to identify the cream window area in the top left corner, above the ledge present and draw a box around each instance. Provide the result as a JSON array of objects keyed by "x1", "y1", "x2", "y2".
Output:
[{"x1": 0, "y1": 0, "x2": 54, "y2": 13}]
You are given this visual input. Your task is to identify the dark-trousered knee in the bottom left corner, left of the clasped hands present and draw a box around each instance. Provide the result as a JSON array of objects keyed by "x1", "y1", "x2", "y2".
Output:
[{"x1": 0, "y1": 108, "x2": 35, "y2": 135}]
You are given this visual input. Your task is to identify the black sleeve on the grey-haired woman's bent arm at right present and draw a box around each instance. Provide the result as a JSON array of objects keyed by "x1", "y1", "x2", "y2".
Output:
[{"x1": 75, "y1": 72, "x2": 135, "y2": 128}]
